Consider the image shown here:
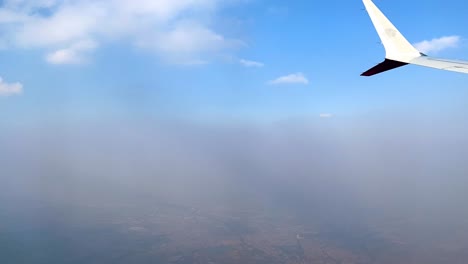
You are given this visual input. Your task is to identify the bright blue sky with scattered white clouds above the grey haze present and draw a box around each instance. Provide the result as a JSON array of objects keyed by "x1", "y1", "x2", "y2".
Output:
[{"x1": 0, "y1": 0, "x2": 468, "y2": 124}]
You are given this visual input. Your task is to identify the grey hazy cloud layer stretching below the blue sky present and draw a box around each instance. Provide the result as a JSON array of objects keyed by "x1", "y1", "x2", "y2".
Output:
[{"x1": 0, "y1": 118, "x2": 468, "y2": 264}]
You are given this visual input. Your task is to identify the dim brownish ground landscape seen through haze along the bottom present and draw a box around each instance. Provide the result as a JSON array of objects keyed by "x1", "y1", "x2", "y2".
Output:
[{"x1": 0, "y1": 192, "x2": 467, "y2": 264}]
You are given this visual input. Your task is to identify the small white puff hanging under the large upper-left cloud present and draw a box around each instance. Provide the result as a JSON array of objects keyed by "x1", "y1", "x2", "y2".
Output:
[{"x1": 46, "y1": 40, "x2": 97, "y2": 64}]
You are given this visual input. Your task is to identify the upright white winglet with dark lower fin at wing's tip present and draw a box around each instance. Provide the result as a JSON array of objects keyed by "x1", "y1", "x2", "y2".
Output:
[{"x1": 362, "y1": 0, "x2": 422, "y2": 76}]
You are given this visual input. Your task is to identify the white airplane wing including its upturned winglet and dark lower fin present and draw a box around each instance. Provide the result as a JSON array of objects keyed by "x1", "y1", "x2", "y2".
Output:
[{"x1": 361, "y1": 0, "x2": 468, "y2": 76}]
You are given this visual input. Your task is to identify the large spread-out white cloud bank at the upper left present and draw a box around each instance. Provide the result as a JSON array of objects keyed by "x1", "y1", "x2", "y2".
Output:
[{"x1": 0, "y1": 0, "x2": 243, "y2": 64}]
